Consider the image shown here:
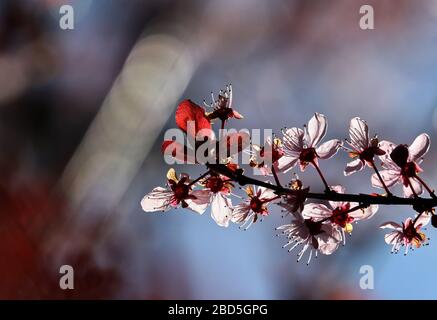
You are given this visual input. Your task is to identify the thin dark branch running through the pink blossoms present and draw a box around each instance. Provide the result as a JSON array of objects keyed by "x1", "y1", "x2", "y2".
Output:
[{"x1": 207, "y1": 164, "x2": 437, "y2": 212}]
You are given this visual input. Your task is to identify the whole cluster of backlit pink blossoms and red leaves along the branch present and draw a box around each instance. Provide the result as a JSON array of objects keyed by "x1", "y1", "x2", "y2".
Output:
[{"x1": 141, "y1": 86, "x2": 437, "y2": 263}]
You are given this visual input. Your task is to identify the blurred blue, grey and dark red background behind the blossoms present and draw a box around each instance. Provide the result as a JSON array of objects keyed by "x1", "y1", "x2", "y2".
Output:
[{"x1": 0, "y1": 0, "x2": 437, "y2": 299}]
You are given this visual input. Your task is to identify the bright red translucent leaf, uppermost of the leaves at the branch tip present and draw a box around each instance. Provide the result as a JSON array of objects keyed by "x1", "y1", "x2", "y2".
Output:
[{"x1": 176, "y1": 100, "x2": 212, "y2": 137}]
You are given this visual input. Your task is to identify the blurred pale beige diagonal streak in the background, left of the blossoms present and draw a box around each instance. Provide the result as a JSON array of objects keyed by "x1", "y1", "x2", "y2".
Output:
[{"x1": 62, "y1": 34, "x2": 195, "y2": 214}]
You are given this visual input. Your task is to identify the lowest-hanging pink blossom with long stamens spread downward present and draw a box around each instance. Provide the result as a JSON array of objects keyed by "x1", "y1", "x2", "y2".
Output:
[{"x1": 276, "y1": 213, "x2": 341, "y2": 265}]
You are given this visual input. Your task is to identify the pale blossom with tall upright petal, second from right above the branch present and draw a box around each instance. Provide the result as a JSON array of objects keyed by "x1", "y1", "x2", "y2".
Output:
[{"x1": 344, "y1": 117, "x2": 385, "y2": 176}]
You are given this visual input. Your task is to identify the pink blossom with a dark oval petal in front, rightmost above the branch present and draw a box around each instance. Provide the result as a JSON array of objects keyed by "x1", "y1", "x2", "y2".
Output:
[{"x1": 371, "y1": 133, "x2": 430, "y2": 198}]
